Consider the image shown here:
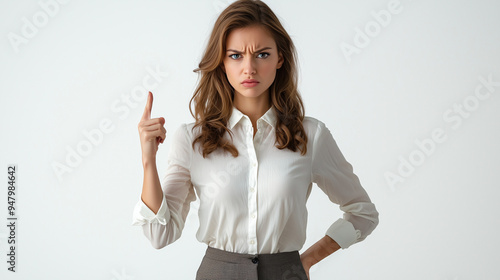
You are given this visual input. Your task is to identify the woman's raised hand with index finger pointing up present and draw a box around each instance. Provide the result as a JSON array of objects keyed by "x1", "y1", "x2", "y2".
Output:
[{"x1": 138, "y1": 92, "x2": 167, "y2": 164}]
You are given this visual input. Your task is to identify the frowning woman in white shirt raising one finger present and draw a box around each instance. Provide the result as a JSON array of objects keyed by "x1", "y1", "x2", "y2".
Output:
[{"x1": 133, "y1": 0, "x2": 378, "y2": 280}]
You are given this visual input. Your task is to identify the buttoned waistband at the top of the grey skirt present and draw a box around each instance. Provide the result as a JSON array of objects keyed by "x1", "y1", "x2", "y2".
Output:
[{"x1": 205, "y1": 246, "x2": 300, "y2": 263}]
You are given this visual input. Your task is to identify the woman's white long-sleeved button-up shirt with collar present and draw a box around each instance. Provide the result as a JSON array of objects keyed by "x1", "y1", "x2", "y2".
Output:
[{"x1": 132, "y1": 106, "x2": 378, "y2": 254}]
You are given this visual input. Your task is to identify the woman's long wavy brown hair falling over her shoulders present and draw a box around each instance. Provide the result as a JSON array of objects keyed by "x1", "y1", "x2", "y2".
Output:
[{"x1": 189, "y1": 0, "x2": 307, "y2": 158}]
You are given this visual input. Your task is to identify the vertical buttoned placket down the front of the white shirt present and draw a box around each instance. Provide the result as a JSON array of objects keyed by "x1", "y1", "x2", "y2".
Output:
[{"x1": 245, "y1": 120, "x2": 259, "y2": 254}]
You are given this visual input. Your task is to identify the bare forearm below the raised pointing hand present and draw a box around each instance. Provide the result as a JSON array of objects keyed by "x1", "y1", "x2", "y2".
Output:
[{"x1": 141, "y1": 158, "x2": 163, "y2": 214}]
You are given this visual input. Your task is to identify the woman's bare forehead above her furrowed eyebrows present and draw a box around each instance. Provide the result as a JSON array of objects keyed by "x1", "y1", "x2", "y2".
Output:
[{"x1": 226, "y1": 26, "x2": 276, "y2": 50}]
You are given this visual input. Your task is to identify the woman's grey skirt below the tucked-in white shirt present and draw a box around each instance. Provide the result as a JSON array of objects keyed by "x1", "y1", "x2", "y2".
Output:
[{"x1": 196, "y1": 246, "x2": 307, "y2": 280}]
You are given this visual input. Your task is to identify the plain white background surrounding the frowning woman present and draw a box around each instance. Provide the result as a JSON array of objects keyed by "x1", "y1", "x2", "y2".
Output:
[{"x1": 0, "y1": 0, "x2": 500, "y2": 280}]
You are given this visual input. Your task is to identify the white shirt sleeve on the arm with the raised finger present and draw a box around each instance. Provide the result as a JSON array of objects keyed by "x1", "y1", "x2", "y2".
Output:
[{"x1": 132, "y1": 124, "x2": 196, "y2": 249}]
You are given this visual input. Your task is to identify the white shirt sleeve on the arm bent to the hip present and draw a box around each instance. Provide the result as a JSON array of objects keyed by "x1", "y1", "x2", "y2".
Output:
[{"x1": 312, "y1": 121, "x2": 379, "y2": 249}]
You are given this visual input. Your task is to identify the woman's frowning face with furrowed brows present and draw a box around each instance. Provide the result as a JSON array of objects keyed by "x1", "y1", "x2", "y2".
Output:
[{"x1": 222, "y1": 26, "x2": 283, "y2": 103}]
